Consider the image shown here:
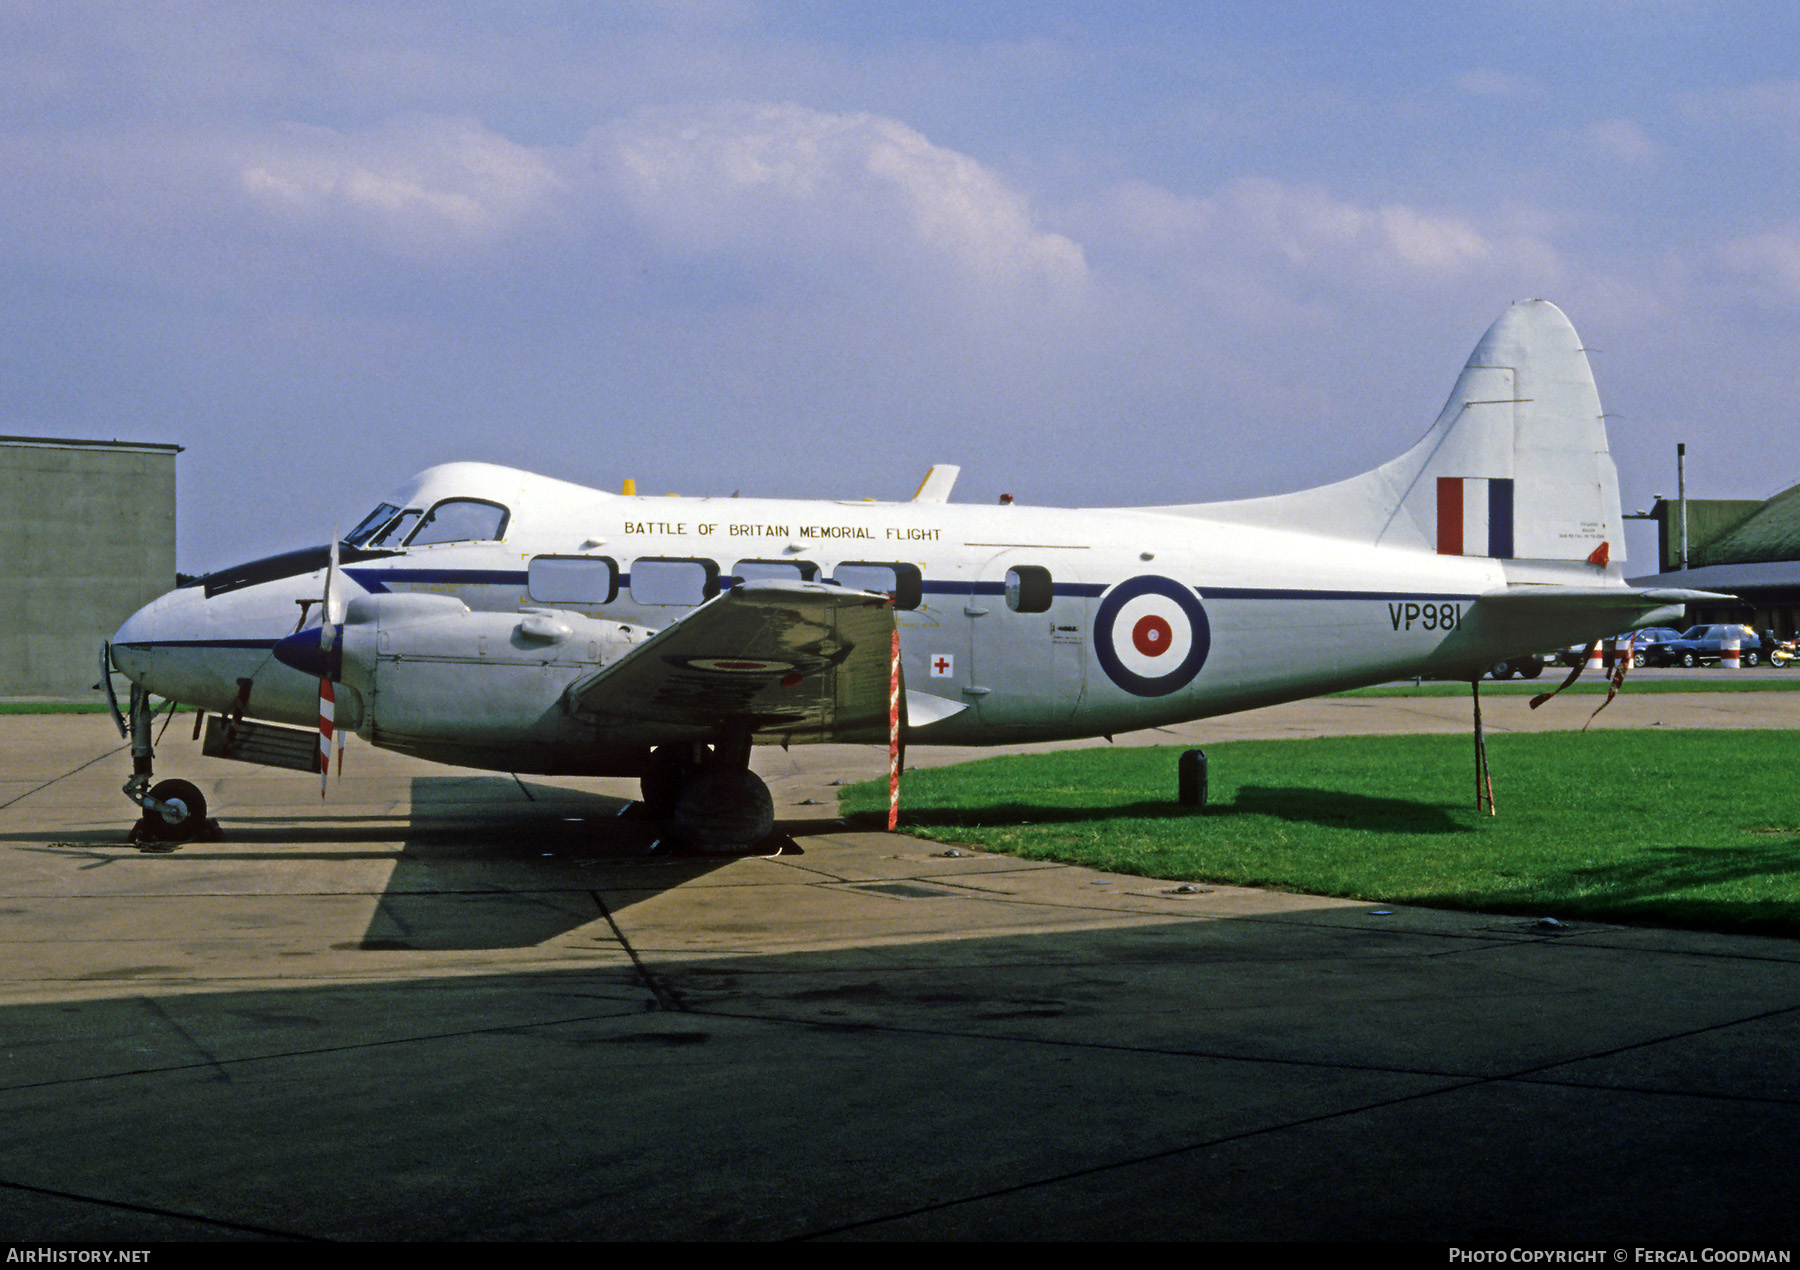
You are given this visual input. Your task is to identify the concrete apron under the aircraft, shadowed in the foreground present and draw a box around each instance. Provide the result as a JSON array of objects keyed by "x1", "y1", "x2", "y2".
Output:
[{"x1": 0, "y1": 693, "x2": 1800, "y2": 1247}]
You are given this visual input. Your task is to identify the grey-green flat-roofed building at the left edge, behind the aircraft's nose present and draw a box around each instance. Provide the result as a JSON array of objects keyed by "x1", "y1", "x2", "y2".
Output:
[{"x1": 0, "y1": 437, "x2": 178, "y2": 698}]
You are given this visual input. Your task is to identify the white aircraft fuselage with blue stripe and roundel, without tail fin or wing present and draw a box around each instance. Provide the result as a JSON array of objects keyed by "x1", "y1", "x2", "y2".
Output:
[{"x1": 113, "y1": 455, "x2": 1656, "y2": 772}]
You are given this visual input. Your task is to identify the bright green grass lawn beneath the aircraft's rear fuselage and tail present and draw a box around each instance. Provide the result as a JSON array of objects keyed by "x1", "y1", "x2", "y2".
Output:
[{"x1": 844, "y1": 730, "x2": 1800, "y2": 935}]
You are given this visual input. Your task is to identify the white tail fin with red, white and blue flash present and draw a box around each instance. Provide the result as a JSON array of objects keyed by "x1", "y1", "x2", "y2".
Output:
[{"x1": 1170, "y1": 300, "x2": 1625, "y2": 565}]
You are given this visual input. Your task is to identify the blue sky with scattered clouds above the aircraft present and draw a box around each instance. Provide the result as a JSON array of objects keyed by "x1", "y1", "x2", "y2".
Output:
[{"x1": 0, "y1": 0, "x2": 1800, "y2": 570}]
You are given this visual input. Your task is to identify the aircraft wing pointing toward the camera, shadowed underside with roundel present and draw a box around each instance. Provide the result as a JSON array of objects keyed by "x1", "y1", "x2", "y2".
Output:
[{"x1": 569, "y1": 581, "x2": 895, "y2": 741}]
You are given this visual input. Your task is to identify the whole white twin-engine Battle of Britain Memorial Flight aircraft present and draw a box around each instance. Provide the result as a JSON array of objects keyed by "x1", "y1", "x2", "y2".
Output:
[{"x1": 110, "y1": 300, "x2": 1703, "y2": 849}]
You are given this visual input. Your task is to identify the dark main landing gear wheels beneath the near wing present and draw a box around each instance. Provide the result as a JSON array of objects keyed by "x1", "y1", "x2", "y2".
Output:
[{"x1": 641, "y1": 720, "x2": 797, "y2": 853}]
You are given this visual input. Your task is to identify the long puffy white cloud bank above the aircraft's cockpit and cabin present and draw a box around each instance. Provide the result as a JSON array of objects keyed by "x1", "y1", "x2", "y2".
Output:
[{"x1": 238, "y1": 104, "x2": 1087, "y2": 300}]
